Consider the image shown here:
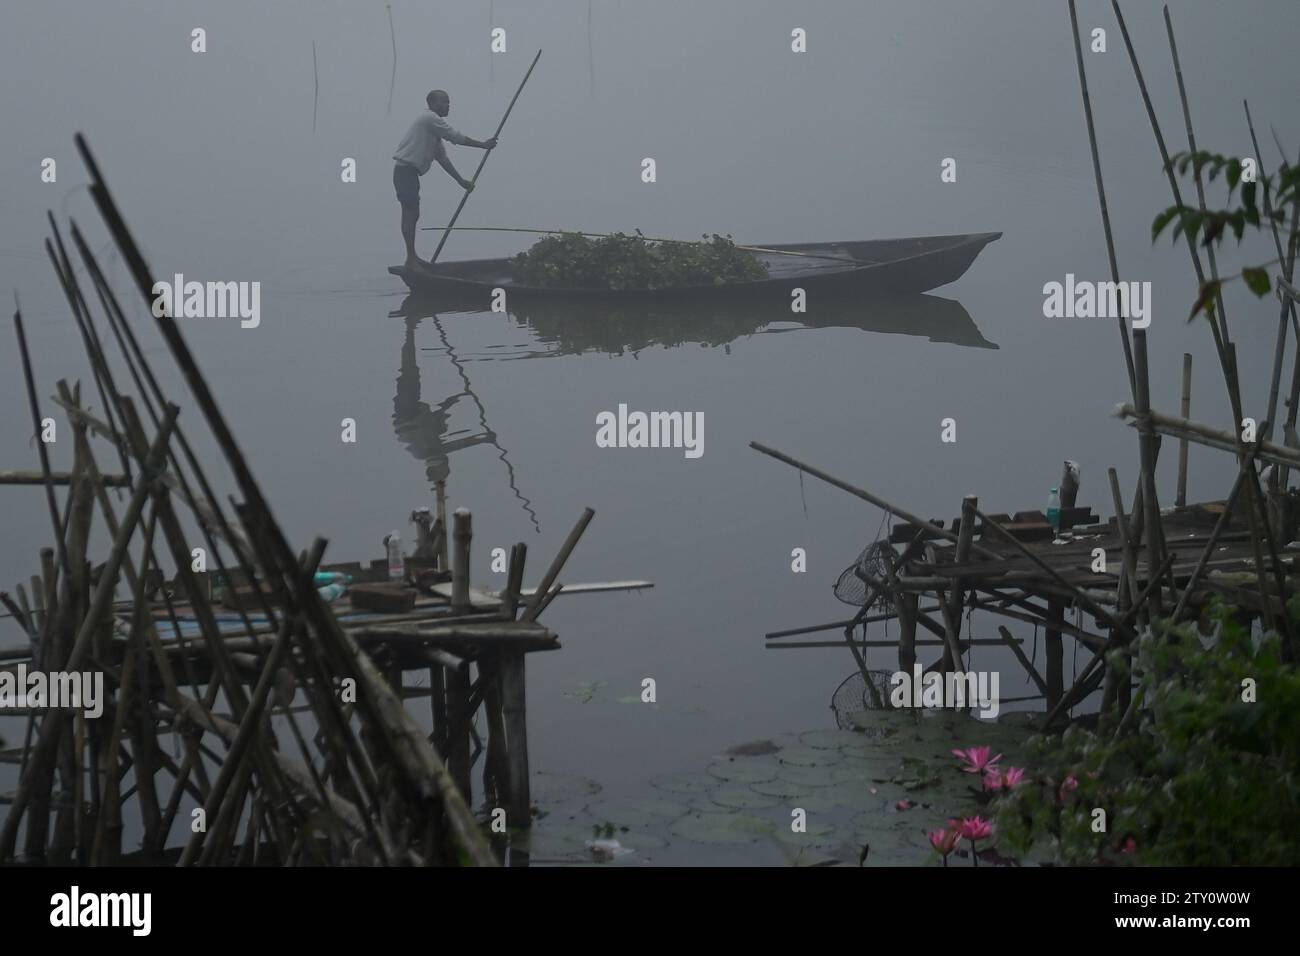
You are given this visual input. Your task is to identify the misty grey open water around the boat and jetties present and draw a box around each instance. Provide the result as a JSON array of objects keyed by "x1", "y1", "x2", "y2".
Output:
[{"x1": 0, "y1": 0, "x2": 1300, "y2": 832}]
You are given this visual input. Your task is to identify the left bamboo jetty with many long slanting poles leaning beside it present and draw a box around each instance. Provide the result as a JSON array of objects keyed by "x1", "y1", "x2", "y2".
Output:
[{"x1": 0, "y1": 137, "x2": 650, "y2": 865}]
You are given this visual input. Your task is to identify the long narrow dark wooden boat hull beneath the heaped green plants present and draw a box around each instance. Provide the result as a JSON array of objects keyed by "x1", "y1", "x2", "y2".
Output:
[{"x1": 389, "y1": 233, "x2": 1002, "y2": 302}]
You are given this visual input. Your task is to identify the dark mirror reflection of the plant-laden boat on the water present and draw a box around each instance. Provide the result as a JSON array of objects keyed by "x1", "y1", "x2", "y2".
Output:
[{"x1": 399, "y1": 295, "x2": 997, "y2": 354}]
